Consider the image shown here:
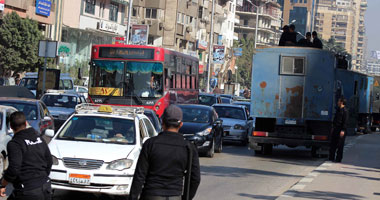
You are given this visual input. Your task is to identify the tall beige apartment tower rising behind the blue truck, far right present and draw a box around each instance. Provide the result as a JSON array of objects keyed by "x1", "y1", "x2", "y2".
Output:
[{"x1": 314, "y1": 0, "x2": 367, "y2": 70}]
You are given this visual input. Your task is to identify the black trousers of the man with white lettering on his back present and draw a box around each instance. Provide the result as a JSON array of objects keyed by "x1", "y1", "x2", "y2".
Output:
[{"x1": 8, "y1": 181, "x2": 52, "y2": 200}]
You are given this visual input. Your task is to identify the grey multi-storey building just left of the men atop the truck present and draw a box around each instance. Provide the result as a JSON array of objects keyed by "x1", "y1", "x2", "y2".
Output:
[{"x1": 235, "y1": 0, "x2": 282, "y2": 46}]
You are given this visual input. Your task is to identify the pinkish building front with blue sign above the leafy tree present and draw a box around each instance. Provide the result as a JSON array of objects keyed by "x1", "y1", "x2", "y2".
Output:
[{"x1": 0, "y1": 0, "x2": 56, "y2": 38}]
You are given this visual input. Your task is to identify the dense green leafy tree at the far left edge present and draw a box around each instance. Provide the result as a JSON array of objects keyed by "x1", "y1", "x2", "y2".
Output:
[{"x1": 0, "y1": 12, "x2": 43, "y2": 72}]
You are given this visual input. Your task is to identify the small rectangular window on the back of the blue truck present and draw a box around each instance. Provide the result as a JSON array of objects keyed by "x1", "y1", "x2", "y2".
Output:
[{"x1": 281, "y1": 56, "x2": 305, "y2": 75}]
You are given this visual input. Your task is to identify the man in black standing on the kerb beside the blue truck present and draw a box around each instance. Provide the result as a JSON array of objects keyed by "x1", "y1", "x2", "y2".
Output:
[{"x1": 329, "y1": 97, "x2": 348, "y2": 162}]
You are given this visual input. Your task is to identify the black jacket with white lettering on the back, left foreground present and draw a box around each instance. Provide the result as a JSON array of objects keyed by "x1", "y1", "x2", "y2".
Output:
[{"x1": 4, "y1": 128, "x2": 53, "y2": 190}]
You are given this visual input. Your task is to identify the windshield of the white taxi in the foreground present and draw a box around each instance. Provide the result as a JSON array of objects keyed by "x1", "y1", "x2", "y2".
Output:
[{"x1": 57, "y1": 116, "x2": 136, "y2": 144}]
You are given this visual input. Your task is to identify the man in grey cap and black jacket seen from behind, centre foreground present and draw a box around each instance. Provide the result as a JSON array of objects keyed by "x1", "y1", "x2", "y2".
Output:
[{"x1": 129, "y1": 105, "x2": 200, "y2": 200}]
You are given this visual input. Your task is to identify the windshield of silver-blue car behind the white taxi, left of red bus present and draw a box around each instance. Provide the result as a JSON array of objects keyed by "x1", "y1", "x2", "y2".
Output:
[{"x1": 41, "y1": 95, "x2": 78, "y2": 108}]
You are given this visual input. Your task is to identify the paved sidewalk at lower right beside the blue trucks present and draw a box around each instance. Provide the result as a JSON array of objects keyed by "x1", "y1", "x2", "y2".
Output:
[{"x1": 277, "y1": 133, "x2": 380, "y2": 200}]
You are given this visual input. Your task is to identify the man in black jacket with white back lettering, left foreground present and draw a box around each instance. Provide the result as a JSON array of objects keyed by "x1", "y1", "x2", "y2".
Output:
[{"x1": 0, "y1": 112, "x2": 53, "y2": 200}]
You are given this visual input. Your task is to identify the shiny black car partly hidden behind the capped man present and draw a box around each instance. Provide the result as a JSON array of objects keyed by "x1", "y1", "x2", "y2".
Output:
[{"x1": 178, "y1": 104, "x2": 223, "y2": 158}]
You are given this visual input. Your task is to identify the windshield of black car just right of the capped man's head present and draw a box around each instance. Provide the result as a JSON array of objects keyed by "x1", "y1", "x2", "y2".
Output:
[{"x1": 181, "y1": 107, "x2": 210, "y2": 123}]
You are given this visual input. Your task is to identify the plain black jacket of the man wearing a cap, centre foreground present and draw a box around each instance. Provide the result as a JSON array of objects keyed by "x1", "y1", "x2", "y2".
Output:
[{"x1": 129, "y1": 132, "x2": 201, "y2": 200}]
